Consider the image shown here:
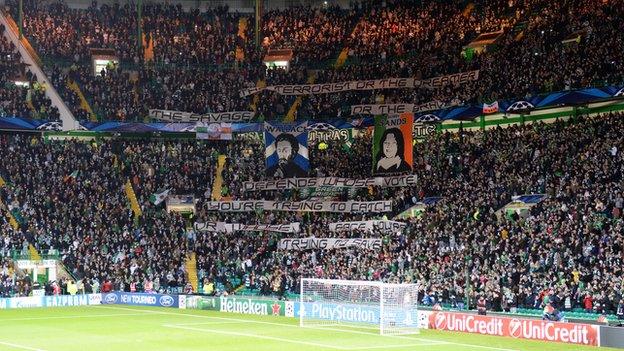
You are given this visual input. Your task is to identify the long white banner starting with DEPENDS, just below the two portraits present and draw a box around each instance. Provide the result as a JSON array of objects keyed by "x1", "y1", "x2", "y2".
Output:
[{"x1": 243, "y1": 174, "x2": 418, "y2": 191}]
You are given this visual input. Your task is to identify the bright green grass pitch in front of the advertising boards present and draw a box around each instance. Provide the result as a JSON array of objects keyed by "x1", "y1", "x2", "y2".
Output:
[{"x1": 0, "y1": 306, "x2": 614, "y2": 351}]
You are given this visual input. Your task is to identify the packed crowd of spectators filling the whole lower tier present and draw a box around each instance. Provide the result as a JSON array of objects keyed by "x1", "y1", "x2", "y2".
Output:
[{"x1": 0, "y1": 114, "x2": 624, "y2": 312}]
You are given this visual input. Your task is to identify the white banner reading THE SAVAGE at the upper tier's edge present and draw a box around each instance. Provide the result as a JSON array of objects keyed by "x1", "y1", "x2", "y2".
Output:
[{"x1": 149, "y1": 110, "x2": 254, "y2": 123}]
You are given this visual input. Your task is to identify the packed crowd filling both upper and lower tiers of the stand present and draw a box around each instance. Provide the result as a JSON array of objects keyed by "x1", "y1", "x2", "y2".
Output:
[{"x1": 0, "y1": 0, "x2": 624, "y2": 326}]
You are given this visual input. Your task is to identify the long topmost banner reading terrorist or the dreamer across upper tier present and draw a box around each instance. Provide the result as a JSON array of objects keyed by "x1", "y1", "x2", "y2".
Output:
[{"x1": 240, "y1": 70, "x2": 479, "y2": 97}]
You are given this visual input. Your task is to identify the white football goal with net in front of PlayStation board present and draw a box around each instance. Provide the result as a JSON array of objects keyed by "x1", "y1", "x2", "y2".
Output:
[{"x1": 299, "y1": 278, "x2": 419, "y2": 335}]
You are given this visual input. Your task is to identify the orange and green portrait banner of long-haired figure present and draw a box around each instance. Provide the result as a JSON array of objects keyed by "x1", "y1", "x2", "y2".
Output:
[{"x1": 373, "y1": 113, "x2": 414, "y2": 175}]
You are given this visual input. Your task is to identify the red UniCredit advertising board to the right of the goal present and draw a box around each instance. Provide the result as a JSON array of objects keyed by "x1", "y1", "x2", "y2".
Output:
[{"x1": 429, "y1": 312, "x2": 600, "y2": 346}]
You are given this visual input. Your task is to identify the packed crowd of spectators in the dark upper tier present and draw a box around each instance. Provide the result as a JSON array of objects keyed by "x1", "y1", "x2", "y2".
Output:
[{"x1": 1, "y1": 0, "x2": 624, "y2": 121}]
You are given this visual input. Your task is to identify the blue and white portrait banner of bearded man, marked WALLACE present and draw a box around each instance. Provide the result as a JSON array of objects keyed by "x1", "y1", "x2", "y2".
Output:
[{"x1": 264, "y1": 122, "x2": 310, "y2": 178}]
